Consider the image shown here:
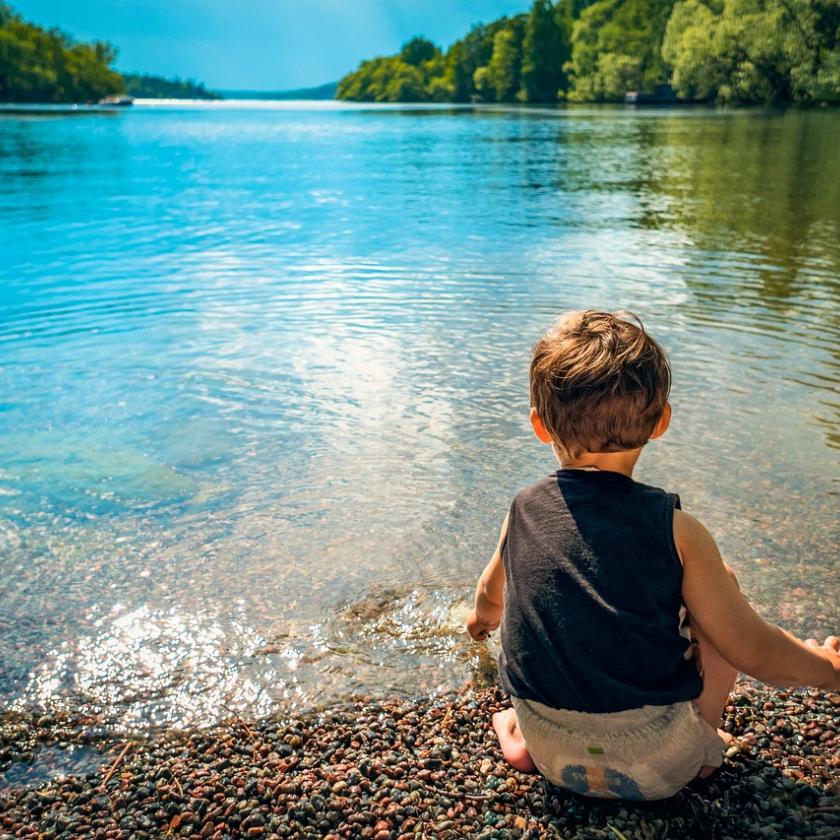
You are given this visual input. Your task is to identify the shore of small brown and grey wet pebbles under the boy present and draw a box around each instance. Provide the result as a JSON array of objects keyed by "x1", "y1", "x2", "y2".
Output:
[{"x1": 0, "y1": 683, "x2": 840, "y2": 840}]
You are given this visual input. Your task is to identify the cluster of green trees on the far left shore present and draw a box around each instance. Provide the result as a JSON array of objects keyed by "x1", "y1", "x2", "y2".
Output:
[{"x1": 0, "y1": 2, "x2": 123, "y2": 103}]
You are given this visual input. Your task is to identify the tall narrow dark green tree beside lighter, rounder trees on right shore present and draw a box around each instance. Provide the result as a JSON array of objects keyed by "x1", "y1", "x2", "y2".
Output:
[{"x1": 522, "y1": 0, "x2": 570, "y2": 102}]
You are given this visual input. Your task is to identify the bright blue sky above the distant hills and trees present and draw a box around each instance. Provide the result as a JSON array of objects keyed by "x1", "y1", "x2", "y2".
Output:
[{"x1": 10, "y1": 0, "x2": 530, "y2": 90}]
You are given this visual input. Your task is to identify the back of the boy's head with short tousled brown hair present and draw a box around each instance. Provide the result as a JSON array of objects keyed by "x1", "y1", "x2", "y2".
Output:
[{"x1": 531, "y1": 309, "x2": 671, "y2": 458}]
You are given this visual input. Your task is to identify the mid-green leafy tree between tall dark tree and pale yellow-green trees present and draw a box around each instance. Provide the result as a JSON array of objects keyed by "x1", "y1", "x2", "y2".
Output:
[{"x1": 566, "y1": 0, "x2": 674, "y2": 102}]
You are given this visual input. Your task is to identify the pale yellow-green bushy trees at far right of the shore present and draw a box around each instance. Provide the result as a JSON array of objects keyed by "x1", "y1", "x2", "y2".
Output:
[{"x1": 662, "y1": 0, "x2": 840, "y2": 103}]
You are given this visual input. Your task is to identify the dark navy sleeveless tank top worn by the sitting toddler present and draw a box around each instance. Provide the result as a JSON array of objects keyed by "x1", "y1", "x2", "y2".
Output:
[{"x1": 499, "y1": 469, "x2": 702, "y2": 712}]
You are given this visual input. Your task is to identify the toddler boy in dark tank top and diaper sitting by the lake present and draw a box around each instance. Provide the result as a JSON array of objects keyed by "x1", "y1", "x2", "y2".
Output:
[{"x1": 467, "y1": 311, "x2": 840, "y2": 799}]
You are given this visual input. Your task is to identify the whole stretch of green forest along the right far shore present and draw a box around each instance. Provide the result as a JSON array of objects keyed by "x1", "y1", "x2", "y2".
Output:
[{"x1": 336, "y1": 0, "x2": 840, "y2": 104}]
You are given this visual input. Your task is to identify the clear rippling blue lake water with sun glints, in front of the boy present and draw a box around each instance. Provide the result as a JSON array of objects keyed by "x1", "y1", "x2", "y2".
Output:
[{"x1": 0, "y1": 104, "x2": 840, "y2": 726}]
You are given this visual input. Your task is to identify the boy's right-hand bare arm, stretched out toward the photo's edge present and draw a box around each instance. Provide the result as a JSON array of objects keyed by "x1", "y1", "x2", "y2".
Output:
[{"x1": 674, "y1": 510, "x2": 840, "y2": 690}]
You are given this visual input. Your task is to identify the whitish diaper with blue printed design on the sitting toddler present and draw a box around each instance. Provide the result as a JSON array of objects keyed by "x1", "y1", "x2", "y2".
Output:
[{"x1": 511, "y1": 697, "x2": 725, "y2": 799}]
